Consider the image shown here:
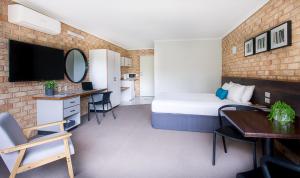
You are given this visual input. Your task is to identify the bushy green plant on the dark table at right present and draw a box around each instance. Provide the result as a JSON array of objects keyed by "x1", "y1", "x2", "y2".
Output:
[{"x1": 268, "y1": 101, "x2": 296, "y2": 122}]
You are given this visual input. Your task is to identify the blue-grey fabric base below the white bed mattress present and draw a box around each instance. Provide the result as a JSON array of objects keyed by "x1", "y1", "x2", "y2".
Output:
[{"x1": 151, "y1": 112, "x2": 228, "y2": 132}]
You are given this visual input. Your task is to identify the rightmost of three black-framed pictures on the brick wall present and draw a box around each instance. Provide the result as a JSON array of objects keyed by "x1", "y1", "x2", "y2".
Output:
[{"x1": 270, "y1": 21, "x2": 292, "y2": 49}]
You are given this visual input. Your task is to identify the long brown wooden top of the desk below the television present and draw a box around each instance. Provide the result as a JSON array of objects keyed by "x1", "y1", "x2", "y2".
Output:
[{"x1": 32, "y1": 88, "x2": 107, "y2": 100}]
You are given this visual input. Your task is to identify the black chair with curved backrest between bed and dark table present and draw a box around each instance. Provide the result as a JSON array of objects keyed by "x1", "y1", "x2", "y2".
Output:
[{"x1": 212, "y1": 105, "x2": 263, "y2": 168}]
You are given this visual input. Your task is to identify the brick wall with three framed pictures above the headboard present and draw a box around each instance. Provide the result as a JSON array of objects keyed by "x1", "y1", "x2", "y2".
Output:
[{"x1": 222, "y1": 0, "x2": 300, "y2": 81}]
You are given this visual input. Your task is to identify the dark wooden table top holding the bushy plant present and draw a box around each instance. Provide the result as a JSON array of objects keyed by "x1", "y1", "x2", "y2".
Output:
[{"x1": 223, "y1": 111, "x2": 300, "y2": 139}]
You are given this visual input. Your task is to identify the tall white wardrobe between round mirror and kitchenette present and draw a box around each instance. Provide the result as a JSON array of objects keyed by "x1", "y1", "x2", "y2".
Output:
[{"x1": 89, "y1": 49, "x2": 121, "y2": 109}]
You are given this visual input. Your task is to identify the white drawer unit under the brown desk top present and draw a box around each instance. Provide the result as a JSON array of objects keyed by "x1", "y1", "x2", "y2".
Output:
[{"x1": 37, "y1": 97, "x2": 81, "y2": 132}]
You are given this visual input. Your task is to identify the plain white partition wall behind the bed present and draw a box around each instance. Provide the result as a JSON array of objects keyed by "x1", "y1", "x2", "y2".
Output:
[{"x1": 154, "y1": 39, "x2": 222, "y2": 95}]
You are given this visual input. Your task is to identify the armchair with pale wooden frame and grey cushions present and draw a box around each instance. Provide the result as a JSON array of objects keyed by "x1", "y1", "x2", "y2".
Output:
[{"x1": 0, "y1": 113, "x2": 74, "y2": 178}]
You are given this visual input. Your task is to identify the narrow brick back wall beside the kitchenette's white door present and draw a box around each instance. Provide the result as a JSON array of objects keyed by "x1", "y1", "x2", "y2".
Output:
[{"x1": 121, "y1": 49, "x2": 154, "y2": 96}]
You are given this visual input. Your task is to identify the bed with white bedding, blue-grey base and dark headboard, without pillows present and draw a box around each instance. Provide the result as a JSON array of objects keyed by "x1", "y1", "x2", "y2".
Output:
[{"x1": 152, "y1": 77, "x2": 300, "y2": 132}]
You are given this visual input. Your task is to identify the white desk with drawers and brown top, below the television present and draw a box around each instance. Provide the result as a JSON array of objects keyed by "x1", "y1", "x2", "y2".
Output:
[{"x1": 33, "y1": 89, "x2": 107, "y2": 133}]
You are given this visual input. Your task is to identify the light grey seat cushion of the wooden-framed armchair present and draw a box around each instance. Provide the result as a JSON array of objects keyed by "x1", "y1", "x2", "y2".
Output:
[{"x1": 22, "y1": 132, "x2": 75, "y2": 165}]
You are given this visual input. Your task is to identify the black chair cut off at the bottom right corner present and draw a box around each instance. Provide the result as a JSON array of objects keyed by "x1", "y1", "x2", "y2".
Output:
[{"x1": 236, "y1": 156, "x2": 300, "y2": 178}]
